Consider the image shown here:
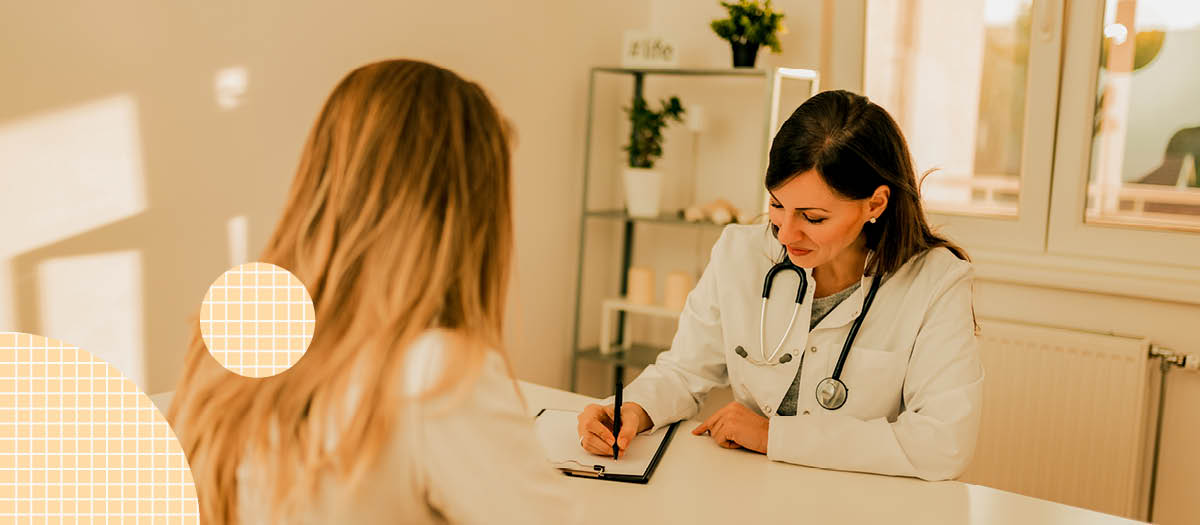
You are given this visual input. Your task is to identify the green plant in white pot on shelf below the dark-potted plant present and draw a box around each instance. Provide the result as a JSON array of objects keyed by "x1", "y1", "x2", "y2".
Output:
[{"x1": 623, "y1": 96, "x2": 684, "y2": 217}]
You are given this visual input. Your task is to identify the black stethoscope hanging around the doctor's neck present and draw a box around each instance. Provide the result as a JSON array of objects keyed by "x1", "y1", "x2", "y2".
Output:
[{"x1": 733, "y1": 255, "x2": 880, "y2": 410}]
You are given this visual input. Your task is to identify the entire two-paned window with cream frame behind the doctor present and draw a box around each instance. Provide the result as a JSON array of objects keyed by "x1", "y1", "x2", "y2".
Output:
[{"x1": 864, "y1": 0, "x2": 1200, "y2": 270}]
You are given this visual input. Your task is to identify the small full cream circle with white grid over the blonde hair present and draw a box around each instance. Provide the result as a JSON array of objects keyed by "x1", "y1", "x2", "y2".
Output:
[{"x1": 200, "y1": 263, "x2": 317, "y2": 378}]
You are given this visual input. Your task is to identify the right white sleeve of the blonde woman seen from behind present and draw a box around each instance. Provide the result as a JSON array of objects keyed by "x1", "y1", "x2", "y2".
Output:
[{"x1": 415, "y1": 352, "x2": 582, "y2": 524}]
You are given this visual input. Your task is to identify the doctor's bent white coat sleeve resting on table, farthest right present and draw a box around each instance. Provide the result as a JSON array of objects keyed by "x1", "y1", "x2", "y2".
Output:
[{"x1": 767, "y1": 265, "x2": 984, "y2": 479}]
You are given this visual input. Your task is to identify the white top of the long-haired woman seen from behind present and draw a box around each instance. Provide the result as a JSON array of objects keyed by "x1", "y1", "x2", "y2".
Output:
[{"x1": 238, "y1": 331, "x2": 575, "y2": 525}]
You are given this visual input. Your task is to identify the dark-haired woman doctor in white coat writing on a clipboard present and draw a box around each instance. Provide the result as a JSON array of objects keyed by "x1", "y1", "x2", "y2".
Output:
[{"x1": 578, "y1": 91, "x2": 984, "y2": 479}]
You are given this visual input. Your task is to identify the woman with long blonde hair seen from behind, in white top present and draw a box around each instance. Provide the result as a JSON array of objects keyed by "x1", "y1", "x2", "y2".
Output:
[{"x1": 169, "y1": 60, "x2": 572, "y2": 524}]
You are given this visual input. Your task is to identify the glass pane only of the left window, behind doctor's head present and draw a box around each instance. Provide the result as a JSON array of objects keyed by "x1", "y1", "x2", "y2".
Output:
[{"x1": 864, "y1": 0, "x2": 1032, "y2": 216}]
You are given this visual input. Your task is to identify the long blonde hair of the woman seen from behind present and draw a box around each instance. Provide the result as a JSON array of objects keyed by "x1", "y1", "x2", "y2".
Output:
[{"x1": 168, "y1": 60, "x2": 512, "y2": 524}]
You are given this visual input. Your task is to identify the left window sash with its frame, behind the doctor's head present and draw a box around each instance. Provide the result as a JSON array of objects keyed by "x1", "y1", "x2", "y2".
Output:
[{"x1": 863, "y1": 0, "x2": 1063, "y2": 252}]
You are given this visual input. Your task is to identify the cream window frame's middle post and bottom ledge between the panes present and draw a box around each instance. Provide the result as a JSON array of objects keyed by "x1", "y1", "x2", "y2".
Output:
[{"x1": 864, "y1": 0, "x2": 1200, "y2": 304}]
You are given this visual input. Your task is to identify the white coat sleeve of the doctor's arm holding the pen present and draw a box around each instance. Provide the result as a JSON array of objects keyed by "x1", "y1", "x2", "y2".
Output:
[{"x1": 624, "y1": 229, "x2": 730, "y2": 429}]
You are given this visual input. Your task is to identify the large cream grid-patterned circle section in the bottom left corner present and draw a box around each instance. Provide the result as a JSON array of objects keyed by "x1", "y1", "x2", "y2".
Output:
[{"x1": 0, "y1": 332, "x2": 199, "y2": 524}]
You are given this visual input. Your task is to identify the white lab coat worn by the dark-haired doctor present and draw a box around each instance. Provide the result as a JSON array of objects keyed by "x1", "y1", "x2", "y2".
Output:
[{"x1": 625, "y1": 225, "x2": 984, "y2": 479}]
